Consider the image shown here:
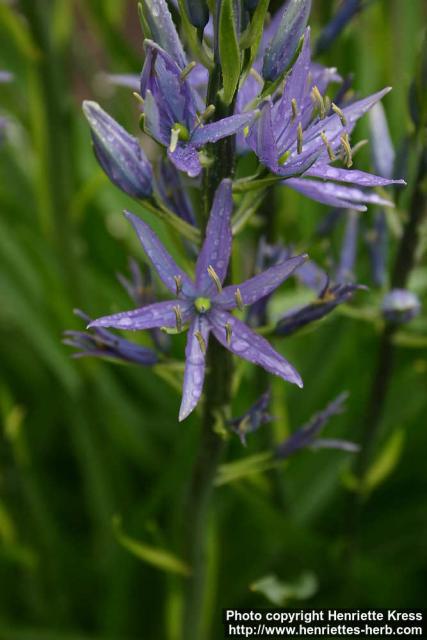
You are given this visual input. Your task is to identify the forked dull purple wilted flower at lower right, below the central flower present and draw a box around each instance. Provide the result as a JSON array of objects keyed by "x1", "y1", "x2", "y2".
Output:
[{"x1": 275, "y1": 393, "x2": 360, "y2": 459}]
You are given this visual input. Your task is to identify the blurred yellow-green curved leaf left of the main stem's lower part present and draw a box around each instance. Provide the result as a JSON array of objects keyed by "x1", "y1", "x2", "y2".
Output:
[{"x1": 113, "y1": 517, "x2": 191, "y2": 576}]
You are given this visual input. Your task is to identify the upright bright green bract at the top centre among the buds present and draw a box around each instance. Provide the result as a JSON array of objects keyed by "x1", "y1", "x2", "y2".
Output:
[{"x1": 218, "y1": 0, "x2": 240, "y2": 105}]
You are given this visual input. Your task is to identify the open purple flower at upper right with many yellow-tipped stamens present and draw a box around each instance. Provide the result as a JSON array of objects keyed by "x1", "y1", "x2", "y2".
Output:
[{"x1": 247, "y1": 29, "x2": 405, "y2": 211}]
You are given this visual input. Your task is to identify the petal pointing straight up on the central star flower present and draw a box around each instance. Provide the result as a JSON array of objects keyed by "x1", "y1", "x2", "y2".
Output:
[{"x1": 196, "y1": 180, "x2": 233, "y2": 296}]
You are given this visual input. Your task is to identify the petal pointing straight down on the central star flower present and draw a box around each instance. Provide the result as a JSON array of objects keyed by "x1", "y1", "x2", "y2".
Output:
[{"x1": 179, "y1": 315, "x2": 209, "y2": 422}]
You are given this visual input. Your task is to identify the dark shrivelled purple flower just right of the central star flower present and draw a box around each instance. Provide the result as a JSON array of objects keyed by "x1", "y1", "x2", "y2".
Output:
[{"x1": 274, "y1": 284, "x2": 366, "y2": 336}]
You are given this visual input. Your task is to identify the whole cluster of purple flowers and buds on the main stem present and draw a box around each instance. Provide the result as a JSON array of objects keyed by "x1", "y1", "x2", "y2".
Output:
[{"x1": 67, "y1": 0, "x2": 403, "y2": 432}]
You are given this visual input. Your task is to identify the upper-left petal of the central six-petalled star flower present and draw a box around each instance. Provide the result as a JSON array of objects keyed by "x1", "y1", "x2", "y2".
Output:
[{"x1": 125, "y1": 211, "x2": 194, "y2": 296}]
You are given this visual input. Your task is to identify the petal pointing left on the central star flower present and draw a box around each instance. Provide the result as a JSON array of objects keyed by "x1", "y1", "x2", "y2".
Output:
[{"x1": 88, "y1": 300, "x2": 192, "y2": 331}]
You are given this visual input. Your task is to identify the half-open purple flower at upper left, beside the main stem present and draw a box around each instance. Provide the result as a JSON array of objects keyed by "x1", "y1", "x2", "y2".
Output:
[{"x1": 141, "y1": 40, "x2": 255, "y2": 178}]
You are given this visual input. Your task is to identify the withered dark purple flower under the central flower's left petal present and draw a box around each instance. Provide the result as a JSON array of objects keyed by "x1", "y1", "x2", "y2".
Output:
[{"x1": 64, "y1": 309, "x2": 158, "y2": 366}]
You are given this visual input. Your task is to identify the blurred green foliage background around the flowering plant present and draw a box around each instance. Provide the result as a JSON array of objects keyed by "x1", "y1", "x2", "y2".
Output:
[{"x1": 0, "y1": 0, "x2": 427, "y2": 640}]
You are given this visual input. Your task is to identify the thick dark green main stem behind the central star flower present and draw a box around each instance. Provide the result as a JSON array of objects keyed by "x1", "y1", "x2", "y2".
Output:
[{"x1": 182, "y1": 60, "x2": 235, "y2": 640}]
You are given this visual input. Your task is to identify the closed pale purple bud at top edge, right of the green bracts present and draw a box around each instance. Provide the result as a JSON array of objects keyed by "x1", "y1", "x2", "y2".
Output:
[{"x1": 262, "y1": 0, "x2": 311, "y2": 82}]
